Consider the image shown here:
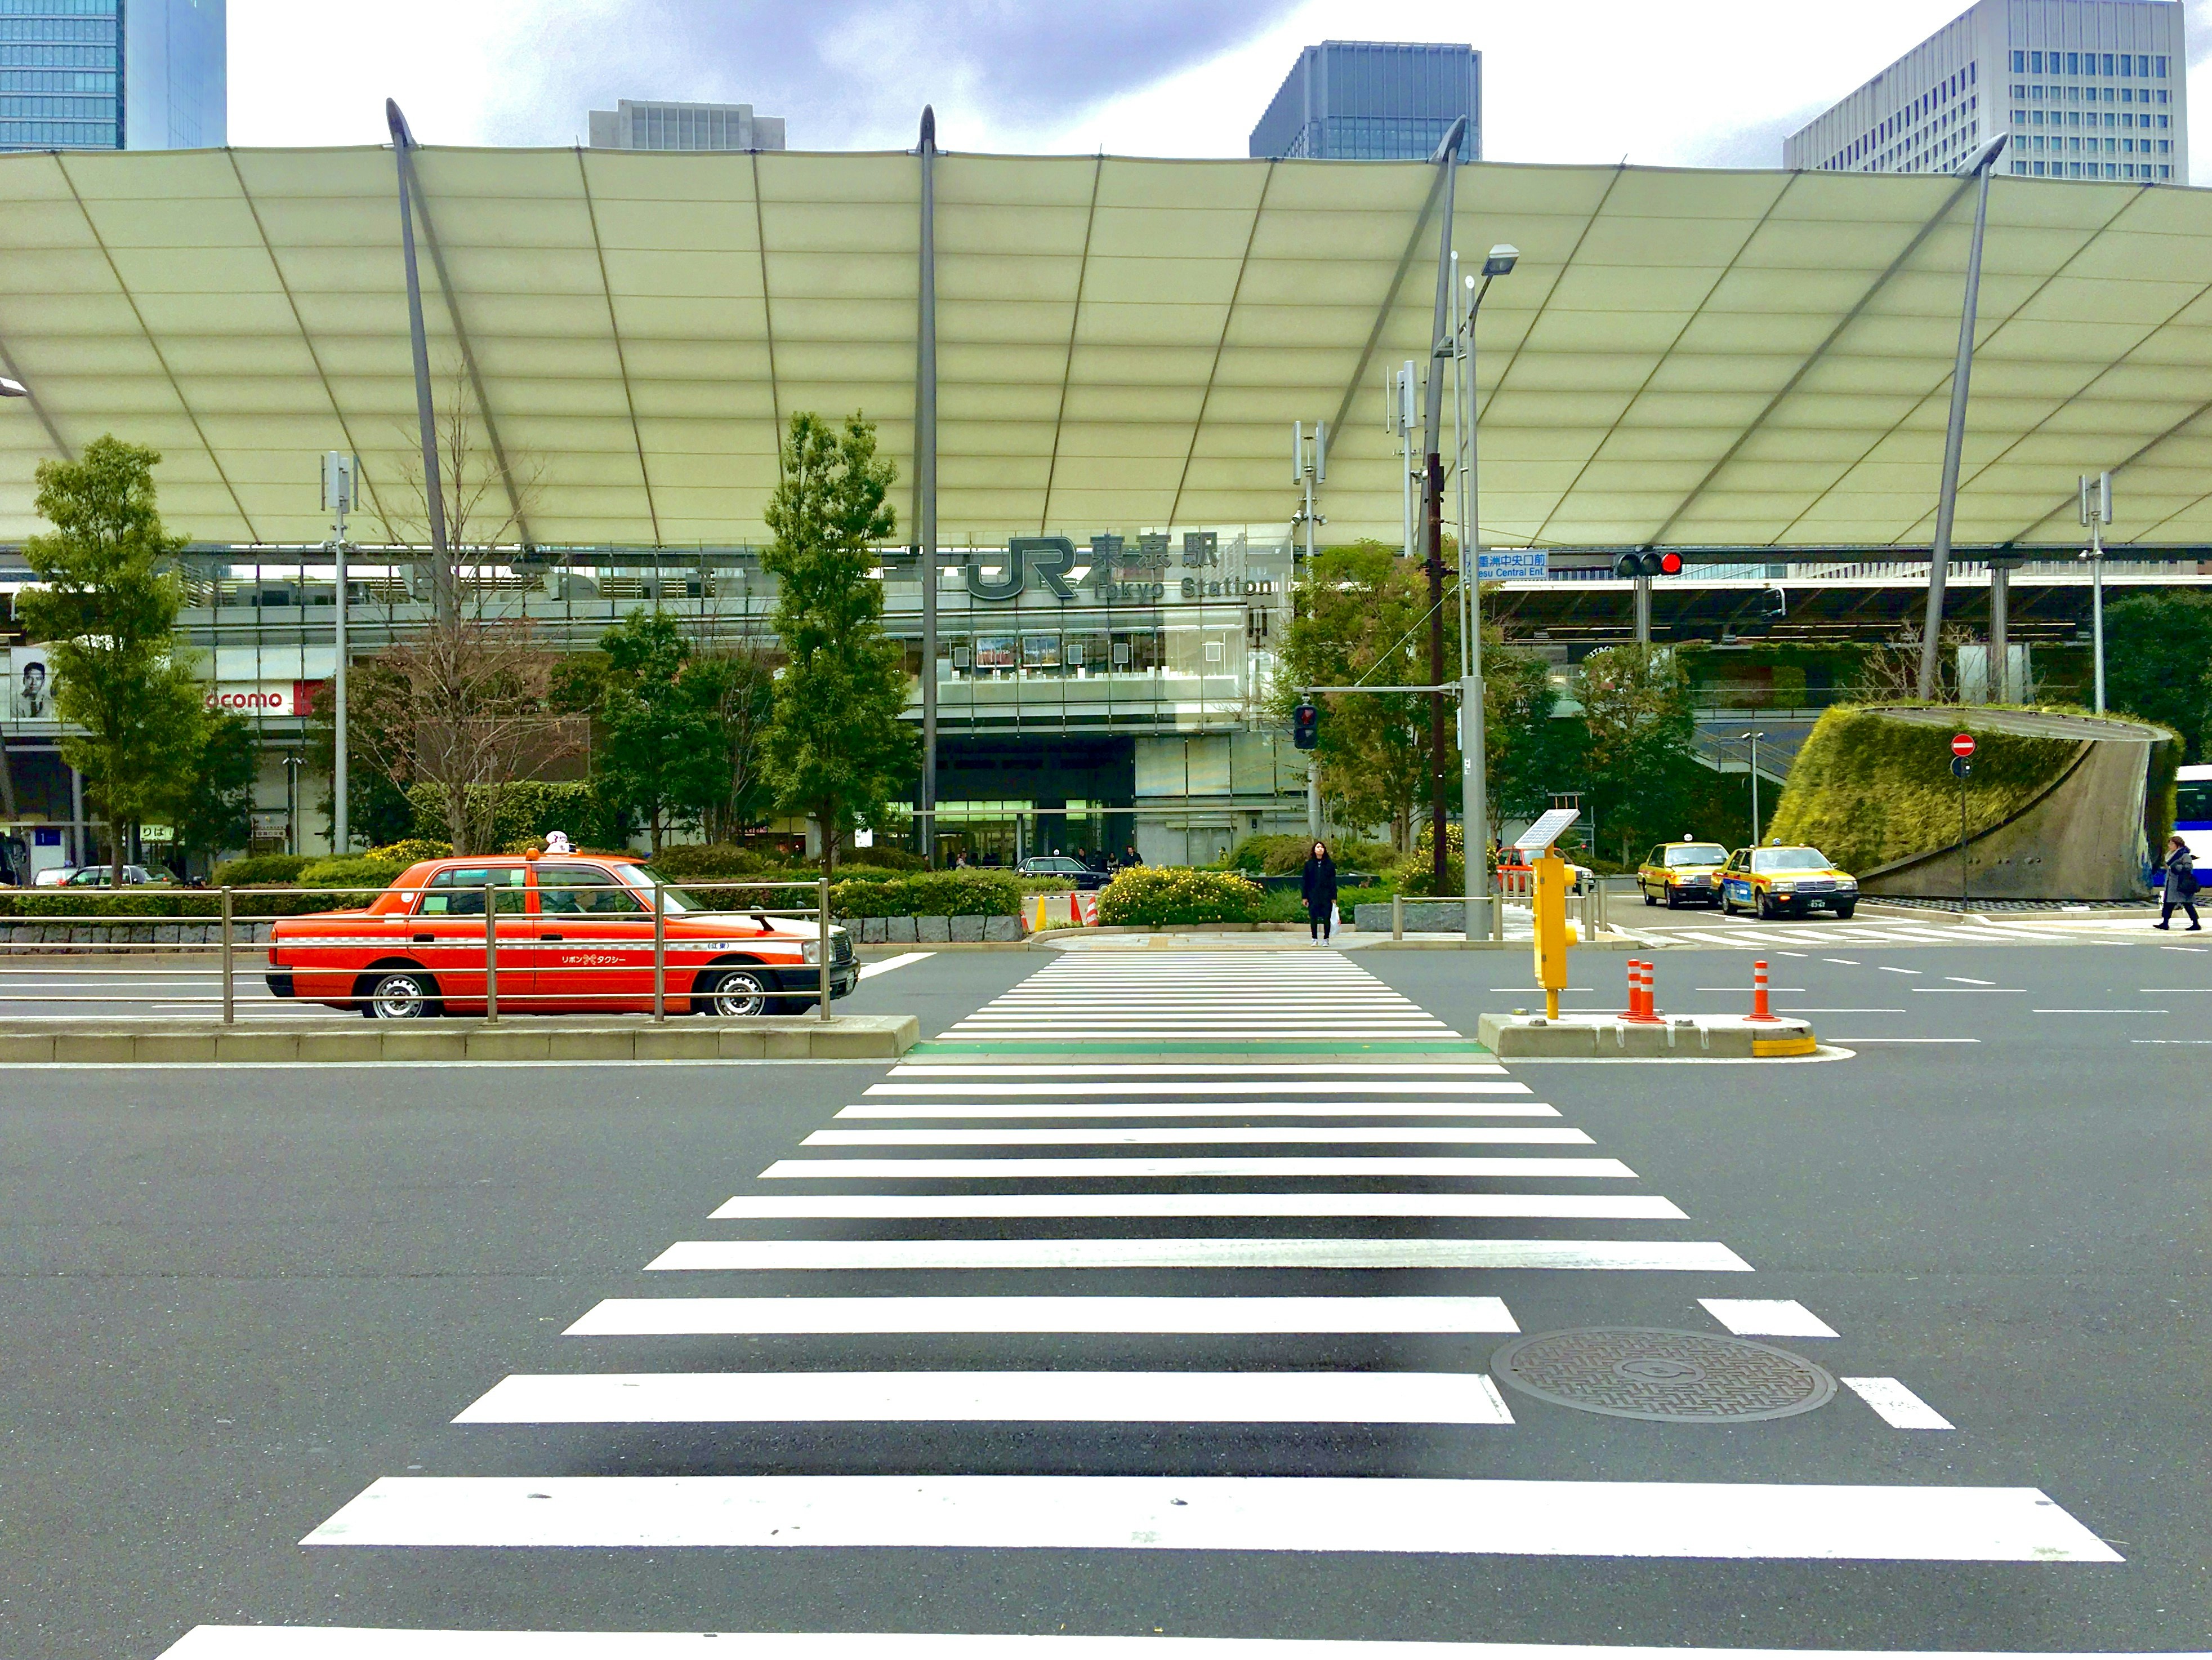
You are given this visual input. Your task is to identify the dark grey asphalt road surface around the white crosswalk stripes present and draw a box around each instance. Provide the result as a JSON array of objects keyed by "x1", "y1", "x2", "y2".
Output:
[{"x1": 0, "y1": 945, "x2": 2212, "y2": 1658}]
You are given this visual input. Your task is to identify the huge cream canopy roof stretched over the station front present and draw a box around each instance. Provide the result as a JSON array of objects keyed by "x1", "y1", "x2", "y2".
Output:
[{"x1": 0, "y1": 148, "x2": 2212, "y2": 547}]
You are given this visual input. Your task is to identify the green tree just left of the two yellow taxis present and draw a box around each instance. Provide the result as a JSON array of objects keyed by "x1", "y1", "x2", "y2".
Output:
[{"x1": 1575, "y1": 646, "x2": 1699, "y2": 863}]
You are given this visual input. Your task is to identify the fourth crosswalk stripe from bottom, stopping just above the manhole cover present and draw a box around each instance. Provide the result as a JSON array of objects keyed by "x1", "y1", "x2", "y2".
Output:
[{"x1": 564, "y1": 1297, "x2": 1520, "y2": 1337}]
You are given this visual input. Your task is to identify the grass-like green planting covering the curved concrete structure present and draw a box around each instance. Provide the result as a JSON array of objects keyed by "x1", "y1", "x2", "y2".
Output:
[{"x1": 1765, "y1": 704, "x2": 2077, "y2": 872}]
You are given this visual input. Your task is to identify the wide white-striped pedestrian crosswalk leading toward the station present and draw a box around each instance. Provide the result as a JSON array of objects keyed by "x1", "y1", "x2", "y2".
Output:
[{"x1": 170, "y1": 952, "x2": 2119, "y2": 1660}]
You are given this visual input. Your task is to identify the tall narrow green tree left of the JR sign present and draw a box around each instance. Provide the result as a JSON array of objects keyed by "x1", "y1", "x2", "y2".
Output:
[{"x1": 761, "y1": 412, "x2": 918, "y2": 872}]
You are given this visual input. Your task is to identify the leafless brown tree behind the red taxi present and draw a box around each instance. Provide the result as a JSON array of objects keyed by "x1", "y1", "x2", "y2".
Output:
[{"x1": 347, "y1": 370, "x2": 588, "y2": 852}]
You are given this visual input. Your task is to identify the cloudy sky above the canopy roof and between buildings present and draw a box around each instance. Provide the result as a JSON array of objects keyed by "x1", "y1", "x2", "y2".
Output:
[{"x1": 230, "y1": 0, "x2": 2212, "y2": 179}]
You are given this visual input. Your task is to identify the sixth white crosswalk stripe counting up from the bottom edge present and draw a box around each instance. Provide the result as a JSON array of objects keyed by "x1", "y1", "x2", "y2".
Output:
[{"x1": 710, "y1": 1193, "x2": 1690, "y2": 1222}]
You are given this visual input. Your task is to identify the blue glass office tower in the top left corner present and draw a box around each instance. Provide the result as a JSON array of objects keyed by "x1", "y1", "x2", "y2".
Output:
[{"x1": 0, "y1": 0, "x2": 230, "y2": 150}]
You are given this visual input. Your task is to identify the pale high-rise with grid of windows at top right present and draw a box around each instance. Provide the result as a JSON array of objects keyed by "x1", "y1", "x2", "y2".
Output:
[{"x1": 1783, "y1": 0, "x2": 2190, "y2": 184}]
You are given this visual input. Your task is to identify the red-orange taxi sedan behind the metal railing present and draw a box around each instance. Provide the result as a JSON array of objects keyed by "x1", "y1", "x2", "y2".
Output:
[{"x1": 267, "y1": 855, "x2": 860, "y2": 1020}]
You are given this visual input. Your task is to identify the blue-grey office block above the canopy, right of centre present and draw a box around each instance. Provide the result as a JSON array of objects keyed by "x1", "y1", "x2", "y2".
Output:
[{"x1": 1250, "y1": 40, "x2": 1482, "y2": 162}]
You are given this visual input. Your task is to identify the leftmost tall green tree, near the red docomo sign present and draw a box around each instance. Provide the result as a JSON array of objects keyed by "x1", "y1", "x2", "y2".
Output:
[{"x1": 15, "y1": 436, "x2": 208, "y2": 885}]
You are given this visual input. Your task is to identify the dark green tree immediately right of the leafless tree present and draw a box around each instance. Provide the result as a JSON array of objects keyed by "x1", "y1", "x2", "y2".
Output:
[{"x1": 593, "y1": 607, "x2": 721, "y2": 857}]
